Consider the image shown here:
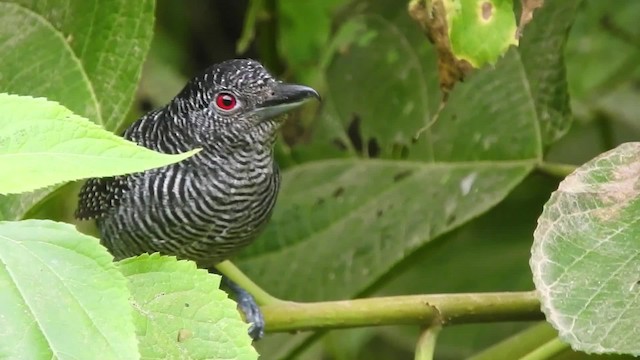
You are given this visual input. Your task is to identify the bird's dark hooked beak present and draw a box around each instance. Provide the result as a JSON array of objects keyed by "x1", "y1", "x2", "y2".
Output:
[{"x1": 254, "y1": 83, "x2": 320, "y2": 119}]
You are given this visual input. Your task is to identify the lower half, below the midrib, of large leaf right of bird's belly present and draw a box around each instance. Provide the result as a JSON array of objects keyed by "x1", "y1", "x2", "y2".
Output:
[{"x1": 241, "y1": 160, "x2": 532, "y2": 300}]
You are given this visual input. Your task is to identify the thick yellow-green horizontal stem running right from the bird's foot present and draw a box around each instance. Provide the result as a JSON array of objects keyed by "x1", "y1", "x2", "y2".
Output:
[{"x1": 260, "y1": 290, "x2": 544, "y2": 333}]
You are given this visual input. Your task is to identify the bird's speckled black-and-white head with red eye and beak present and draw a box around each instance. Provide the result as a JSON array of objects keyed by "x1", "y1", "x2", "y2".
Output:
[{"x1": 169, "y1": 59, "x2": 319, "y2": 145}]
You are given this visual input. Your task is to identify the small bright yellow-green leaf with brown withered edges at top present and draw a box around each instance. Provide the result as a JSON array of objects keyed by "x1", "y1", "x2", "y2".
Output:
[{"x1": 442, "y1": 0, "x2": 518, "y2": 68}]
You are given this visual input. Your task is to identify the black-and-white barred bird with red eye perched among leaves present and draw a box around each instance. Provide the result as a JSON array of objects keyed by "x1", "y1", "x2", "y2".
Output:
[{"x1": 75, "y1": 59, "x2": 320, "y2": 339}]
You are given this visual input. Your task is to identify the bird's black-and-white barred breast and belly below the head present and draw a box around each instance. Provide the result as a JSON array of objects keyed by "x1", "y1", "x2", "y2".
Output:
[{"x1": 101, "y1": 148, "x2": 280, "y2": 264}]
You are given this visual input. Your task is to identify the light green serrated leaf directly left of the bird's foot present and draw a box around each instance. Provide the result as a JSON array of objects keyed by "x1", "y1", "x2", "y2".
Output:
[{"x1": 118, "y1": 254, "x2": 258, "y2": 360}]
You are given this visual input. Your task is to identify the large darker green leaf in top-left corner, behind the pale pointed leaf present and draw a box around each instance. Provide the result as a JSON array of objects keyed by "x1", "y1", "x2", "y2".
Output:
[{"x1": 0, "y1": 0, "x2": 155, "y2": 218}]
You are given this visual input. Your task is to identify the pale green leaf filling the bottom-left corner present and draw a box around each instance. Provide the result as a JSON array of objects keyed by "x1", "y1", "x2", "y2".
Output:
[{"x1": 0, "y1": 220, "x2": 139, "y2": 359}]
